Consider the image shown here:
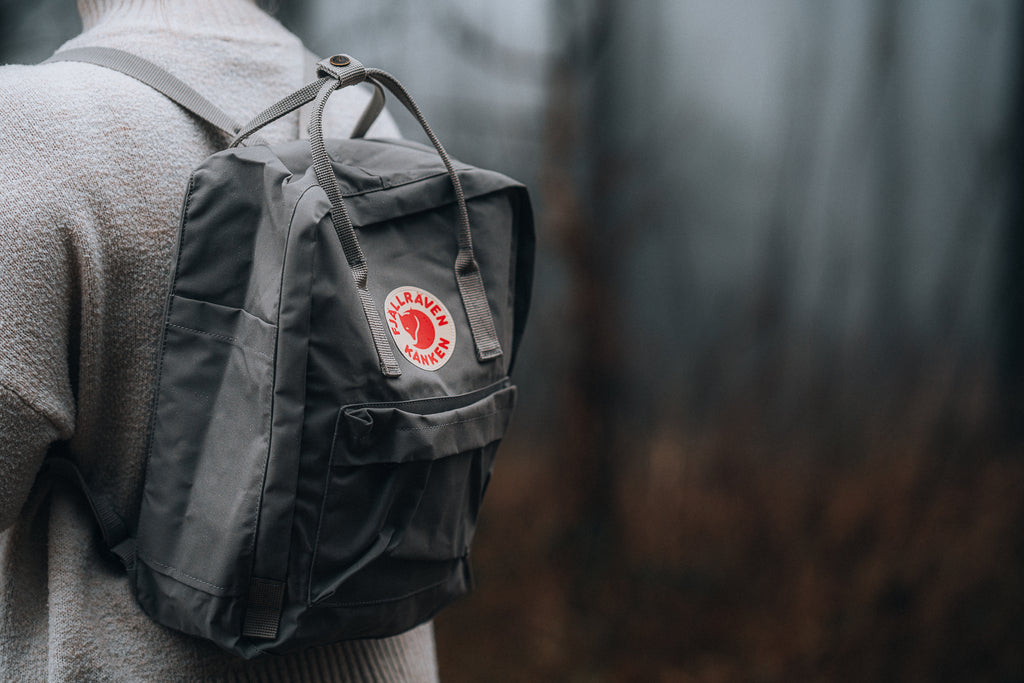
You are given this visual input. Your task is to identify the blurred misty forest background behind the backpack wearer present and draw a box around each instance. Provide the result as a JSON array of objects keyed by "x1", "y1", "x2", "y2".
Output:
[{"x1": 0, "y1": 0, "x2": 1024, "y2": 683}]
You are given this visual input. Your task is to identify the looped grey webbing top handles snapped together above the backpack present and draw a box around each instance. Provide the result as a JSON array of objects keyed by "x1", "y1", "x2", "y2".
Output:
[{"x1": 230, "y1": 54, "x2": 502, "y2": 377}]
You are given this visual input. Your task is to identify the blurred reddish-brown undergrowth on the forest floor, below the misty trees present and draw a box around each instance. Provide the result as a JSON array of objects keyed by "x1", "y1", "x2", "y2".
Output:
[{"x1": 436, "y1": 366, "x2": 1024, "y2": 683}]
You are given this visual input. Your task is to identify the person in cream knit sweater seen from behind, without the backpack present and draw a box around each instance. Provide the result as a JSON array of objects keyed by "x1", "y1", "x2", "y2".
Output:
[{"x1": 0, "y1": 0, "x2": 438, "y2": 681}]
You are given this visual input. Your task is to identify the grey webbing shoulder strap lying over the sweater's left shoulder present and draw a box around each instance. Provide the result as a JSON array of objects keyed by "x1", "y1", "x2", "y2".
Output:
[{"x1": 43, "y1": 47, "x2": 240, "y2": 137}]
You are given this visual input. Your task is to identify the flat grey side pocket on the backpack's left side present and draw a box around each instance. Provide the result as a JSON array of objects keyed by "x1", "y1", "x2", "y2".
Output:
[{"x1": 138, "y1": 296, "x2": 276, "y2": 596}]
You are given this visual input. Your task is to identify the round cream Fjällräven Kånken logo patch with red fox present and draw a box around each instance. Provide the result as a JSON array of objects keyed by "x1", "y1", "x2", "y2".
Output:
[{"x1": 384, "y1": 287, "x2": 455, "y2": 371}]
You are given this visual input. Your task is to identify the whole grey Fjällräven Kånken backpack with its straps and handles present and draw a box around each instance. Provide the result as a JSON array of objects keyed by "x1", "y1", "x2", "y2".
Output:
[{"x1": 44, "y1": 48, "x2": 534, "y2": 658}]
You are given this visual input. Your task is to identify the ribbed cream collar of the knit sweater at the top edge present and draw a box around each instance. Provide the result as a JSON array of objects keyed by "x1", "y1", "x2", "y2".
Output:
[{"x1": 78, "y1": 0, "x2": 284, "y2": 38}]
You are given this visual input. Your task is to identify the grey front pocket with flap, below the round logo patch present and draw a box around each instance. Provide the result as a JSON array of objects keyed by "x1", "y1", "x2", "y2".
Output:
[{"x1": 309, "y1": 379, "x2": 515, "y2": 604}]
